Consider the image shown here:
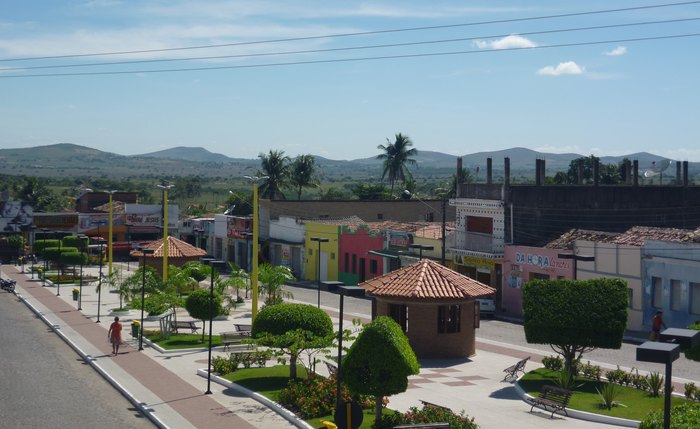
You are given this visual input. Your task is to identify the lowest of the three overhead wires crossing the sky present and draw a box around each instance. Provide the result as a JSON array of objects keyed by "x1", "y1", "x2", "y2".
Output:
[{"x1": 0, "y1": 33, "x2": 700, "y2": 79}]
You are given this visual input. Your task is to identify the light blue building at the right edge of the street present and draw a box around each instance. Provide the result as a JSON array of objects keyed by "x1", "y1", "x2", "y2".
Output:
[{"x1": 642, "y1": 239, "x2": 700, "y2": 329}]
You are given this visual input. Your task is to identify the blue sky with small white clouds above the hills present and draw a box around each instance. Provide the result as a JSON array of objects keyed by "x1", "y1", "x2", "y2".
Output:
[{"x1": 0, "y1": 0, "x2": 700, "y2": 162}]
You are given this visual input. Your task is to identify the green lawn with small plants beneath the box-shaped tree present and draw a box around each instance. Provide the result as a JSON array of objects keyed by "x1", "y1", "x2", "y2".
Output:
[{"x1": 519, "y1": 368, "x2": 687, "y2": 420}]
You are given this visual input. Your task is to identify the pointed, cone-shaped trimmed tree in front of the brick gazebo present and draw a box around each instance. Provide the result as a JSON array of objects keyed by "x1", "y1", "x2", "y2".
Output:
[{"x1": 341, "y1": 316, "x2": 420, "y2": 424}]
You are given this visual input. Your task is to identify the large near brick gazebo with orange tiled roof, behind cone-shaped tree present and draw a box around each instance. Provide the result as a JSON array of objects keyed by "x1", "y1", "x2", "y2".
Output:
[{"x1": 358, "y1": 259, "x2": 496, "y2": 358}]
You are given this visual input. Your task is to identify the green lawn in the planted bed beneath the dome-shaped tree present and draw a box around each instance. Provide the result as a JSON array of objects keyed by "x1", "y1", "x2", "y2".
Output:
[{"x1": 224, "y1": 365, "x2": 394, "y2": 429}]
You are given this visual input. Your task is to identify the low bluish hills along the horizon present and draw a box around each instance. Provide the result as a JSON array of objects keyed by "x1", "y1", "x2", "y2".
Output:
[{"x1": 0, "y1": 143, "x2": 700, "y2": 181}]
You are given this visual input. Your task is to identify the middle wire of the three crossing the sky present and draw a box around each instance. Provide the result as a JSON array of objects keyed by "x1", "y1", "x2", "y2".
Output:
[{"x1": 2, "y1": 17, "x2": 700, "y2": 72}]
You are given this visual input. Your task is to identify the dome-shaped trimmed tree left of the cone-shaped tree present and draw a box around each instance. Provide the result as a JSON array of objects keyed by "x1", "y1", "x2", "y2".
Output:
[{"x1": 251, "y1": 303, "x2": 334, "y2": 379}]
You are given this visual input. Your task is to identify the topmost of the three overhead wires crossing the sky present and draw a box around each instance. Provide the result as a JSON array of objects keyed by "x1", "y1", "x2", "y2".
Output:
[{"x1": 0, "y1": 0, "x2": 700, "y2": 62}]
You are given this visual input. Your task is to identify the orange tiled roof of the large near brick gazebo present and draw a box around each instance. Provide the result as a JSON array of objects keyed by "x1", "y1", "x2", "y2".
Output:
[{"x1": 358, "y1": 259, "x2": 496, "y2": 300}]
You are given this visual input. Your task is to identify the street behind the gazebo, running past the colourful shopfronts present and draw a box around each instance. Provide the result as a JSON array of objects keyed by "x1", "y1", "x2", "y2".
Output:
[{"x1": 286, "y1": 286, "x2": 700, "y2": 384}]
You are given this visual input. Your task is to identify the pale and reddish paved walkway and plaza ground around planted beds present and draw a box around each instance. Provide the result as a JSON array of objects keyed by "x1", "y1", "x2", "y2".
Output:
[{"x1": 1, "y1": 265, "x2": 696, "y2": 429}]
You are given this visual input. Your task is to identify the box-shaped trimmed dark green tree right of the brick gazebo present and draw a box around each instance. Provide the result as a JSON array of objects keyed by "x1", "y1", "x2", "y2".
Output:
[{"x1": 523, "y1": 278, "x2": 628, "y2": 374}]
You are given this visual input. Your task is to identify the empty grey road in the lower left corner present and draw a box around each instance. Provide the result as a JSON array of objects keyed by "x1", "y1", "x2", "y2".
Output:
[{"x1": 0, "y1": 291, "x2": 155, "y2": 429}]
